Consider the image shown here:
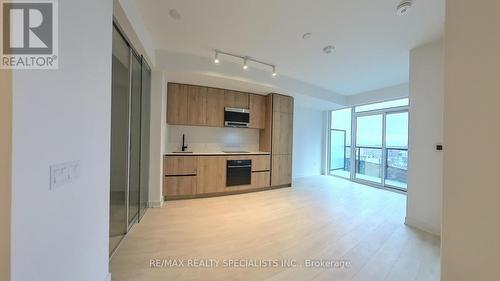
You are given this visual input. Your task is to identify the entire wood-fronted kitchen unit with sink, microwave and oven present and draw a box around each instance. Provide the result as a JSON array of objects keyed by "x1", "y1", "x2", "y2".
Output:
[{"x1": 163, "y1": 83, "x2": 294, "y2": 200}]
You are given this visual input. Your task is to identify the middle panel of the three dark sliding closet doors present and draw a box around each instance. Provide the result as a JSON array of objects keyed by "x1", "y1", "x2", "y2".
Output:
[{"x1": 128, "y1": 51, "x2": 142, "y2": 224}]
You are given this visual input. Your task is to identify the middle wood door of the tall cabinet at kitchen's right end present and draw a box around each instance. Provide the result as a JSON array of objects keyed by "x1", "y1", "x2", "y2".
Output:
[{"x1": 272, "y1": 112, "x2": 293, "y2": 154}]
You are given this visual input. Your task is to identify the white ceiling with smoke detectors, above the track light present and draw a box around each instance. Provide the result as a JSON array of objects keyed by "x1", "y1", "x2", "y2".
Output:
[{"x1": 136, "y1": 0, "x2": 445, "y2": 95}]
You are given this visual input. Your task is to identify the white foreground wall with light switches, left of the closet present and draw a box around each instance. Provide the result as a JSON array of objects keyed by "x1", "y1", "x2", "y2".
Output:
[{"x1": 11, "y1": 0, "x2": 112, "y2": 281}]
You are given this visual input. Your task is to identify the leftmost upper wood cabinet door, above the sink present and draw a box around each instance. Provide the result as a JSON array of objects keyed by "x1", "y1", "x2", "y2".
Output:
[{"x1": 167, "y1": 83, "x2": 188, "y2": 125}]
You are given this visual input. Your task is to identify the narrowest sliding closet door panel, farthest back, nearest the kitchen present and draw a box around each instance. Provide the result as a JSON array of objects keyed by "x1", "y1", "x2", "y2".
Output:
[{"x1": 139, "y1": 59, "x2": 151, "y2": 217}]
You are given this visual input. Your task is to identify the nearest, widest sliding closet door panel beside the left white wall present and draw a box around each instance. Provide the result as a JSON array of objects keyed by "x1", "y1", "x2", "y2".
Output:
[{"x1": 109, "y1": 28, "x2": 130, "y2": 253}]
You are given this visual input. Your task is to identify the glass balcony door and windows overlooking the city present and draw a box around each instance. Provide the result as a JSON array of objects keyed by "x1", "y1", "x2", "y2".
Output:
[{"x1": 328, "y1": 99, "x2": 408, "y2": 191}]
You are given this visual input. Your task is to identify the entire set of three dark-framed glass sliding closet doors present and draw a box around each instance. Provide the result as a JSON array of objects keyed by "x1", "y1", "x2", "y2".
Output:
[{"x1": 109, "y1": 23, "x2": 151, "y2": 255}]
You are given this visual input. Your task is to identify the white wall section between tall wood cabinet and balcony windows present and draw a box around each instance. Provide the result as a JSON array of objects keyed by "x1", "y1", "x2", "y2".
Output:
[{"x1": 292, "y1": 103, "x2": 325, "y2": 178}]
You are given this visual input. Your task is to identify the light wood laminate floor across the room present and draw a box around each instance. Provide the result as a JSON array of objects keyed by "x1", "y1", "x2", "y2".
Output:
[{"x1": 110, "y1": 176, "x2": 439, "y2": 281}]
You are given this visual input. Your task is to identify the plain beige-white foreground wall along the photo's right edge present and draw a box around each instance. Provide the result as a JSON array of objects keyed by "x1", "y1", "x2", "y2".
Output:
[{"x1": 441, "y1": 0, "x2": 500, "y2": 281}]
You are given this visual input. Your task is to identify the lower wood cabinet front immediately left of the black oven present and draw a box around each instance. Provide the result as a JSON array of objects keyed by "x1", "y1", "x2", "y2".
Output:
[{"x1": 196, "y1": 156, "x2": 226, "y2": 194}]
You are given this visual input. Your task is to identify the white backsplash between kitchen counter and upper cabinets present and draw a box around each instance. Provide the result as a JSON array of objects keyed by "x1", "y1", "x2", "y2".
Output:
[{"x1": 167, "y1": 125, "x2": 259, "y2": 152}]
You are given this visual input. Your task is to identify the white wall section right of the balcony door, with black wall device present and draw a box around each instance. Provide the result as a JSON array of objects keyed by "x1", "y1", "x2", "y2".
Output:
[{"x1": 406, "y1": 40, "x2": 444, "y2": 235}]
